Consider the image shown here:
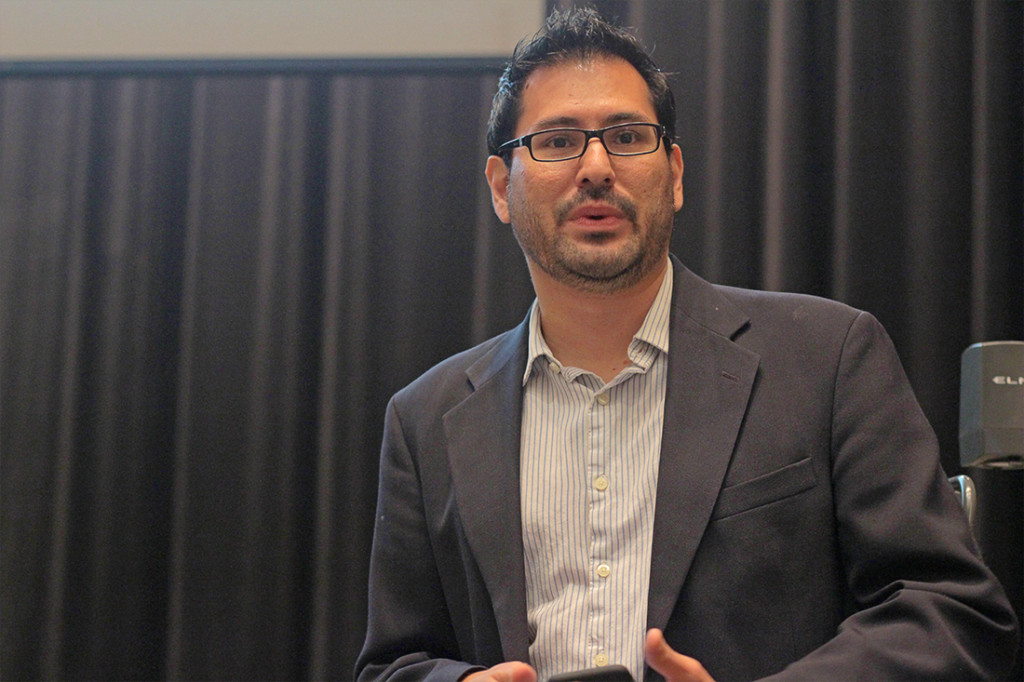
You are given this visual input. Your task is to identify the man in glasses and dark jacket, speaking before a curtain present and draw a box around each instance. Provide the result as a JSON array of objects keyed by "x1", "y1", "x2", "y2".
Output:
[{"x1": 356, "y1": 10, "x2": 1016, "y2": 682}]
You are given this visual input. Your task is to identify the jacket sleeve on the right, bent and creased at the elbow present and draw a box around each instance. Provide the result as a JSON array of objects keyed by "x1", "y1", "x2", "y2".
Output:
[{"x1": 770, "y1": 313, "x2": 1017, "y2": 680}]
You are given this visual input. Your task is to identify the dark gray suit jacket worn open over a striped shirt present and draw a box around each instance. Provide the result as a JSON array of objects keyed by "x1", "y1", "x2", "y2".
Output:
[{"x1": 356, "y1": 259, "x2": 1016, "y2": 681}]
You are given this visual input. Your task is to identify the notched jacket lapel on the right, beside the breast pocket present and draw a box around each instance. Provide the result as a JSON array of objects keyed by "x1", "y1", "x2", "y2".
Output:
[{"x1": 647, "y1": 259, "x2": 759, "y2": 629}]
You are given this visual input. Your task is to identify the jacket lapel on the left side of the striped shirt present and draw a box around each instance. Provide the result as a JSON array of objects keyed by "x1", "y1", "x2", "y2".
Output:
[{"x1": 443, "y1": 323, "x2": 529, "y2": 660}]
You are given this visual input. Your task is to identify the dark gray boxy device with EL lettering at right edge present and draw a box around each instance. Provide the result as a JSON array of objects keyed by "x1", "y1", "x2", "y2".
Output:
[{"x1": 959, "y1": 341, "x2": 1024, "y2": 469}]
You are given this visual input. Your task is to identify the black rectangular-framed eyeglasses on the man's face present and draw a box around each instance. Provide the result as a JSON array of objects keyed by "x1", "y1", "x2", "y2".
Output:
[{"x1": 498, "y1": 123, "x2": 665, "y2": 162}]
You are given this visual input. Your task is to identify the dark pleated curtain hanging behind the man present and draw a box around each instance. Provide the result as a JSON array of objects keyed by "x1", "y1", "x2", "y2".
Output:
[{"x1": 0, "y1": 0, "x2": 1024, "y2": 680}]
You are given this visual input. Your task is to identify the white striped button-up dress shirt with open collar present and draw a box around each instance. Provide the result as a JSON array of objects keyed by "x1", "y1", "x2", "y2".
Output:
[{"x1": 520, "y1": 266, "x2": 672, "y2": 680}]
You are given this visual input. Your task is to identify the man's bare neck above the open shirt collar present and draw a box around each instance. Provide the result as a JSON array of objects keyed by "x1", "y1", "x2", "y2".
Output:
[{"x1": 534, "y1": 258, "x2": 669, "y2": 382}]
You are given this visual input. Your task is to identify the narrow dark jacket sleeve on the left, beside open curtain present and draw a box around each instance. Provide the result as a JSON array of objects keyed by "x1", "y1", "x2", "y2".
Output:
[{"x1": 355, "y1": 399, "x2": 471, "y2": 681}]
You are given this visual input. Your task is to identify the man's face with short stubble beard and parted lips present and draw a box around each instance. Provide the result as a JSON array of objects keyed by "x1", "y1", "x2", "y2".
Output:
[{"x1": 486, "y1": 56, "x2": 683, "y2": 293}]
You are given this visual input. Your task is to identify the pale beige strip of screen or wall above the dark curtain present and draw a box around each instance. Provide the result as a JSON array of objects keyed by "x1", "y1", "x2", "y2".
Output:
[{"x1": 0, "y1": 0, "x2": 545, "y2": 60}]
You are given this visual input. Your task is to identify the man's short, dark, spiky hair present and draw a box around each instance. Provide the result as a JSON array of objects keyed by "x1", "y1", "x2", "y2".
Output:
[{"x1": 487, "y1": 7, "x2": 676, "y2": 164}]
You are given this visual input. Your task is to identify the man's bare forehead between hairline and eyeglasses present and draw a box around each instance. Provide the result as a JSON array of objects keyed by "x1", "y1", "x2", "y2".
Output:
[{"x1": 516, "y1": 56, "x2": 657, "y2": 135}]
